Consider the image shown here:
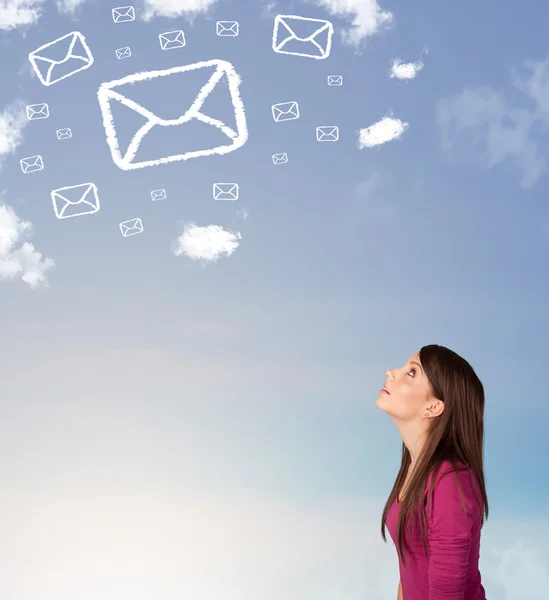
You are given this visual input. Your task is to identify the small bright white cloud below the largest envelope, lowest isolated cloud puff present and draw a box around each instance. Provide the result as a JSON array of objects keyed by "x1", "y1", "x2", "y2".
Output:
[{"x1": 172, "y1": 223, "x2": 242, "y2": 262}]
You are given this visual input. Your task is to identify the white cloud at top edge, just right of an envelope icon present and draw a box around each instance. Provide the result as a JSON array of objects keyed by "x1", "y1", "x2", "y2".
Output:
[{"x1": 315, "y1": 0, "x2": 394, "y2": 46}]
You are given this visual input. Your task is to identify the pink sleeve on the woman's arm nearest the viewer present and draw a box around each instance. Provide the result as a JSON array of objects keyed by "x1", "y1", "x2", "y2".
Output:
[{"x1": 427, "y1": 466, "x2": 474, "y2": 600}]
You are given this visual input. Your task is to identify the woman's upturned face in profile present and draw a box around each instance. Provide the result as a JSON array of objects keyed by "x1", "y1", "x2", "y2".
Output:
[{"x1": 376, "y1": 352, "x2": 432, "y2": 421}]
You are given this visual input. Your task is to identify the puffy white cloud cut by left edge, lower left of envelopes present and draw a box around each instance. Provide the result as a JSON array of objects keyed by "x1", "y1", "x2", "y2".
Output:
[{"x1": 0, "y1": 204, "x2": 55, "y2": 288}]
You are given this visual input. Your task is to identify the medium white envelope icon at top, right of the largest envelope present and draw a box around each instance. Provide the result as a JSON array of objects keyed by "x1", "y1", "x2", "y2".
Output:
[{"x1": 273, "y1": 15, "x2": 334, "y2": 59}]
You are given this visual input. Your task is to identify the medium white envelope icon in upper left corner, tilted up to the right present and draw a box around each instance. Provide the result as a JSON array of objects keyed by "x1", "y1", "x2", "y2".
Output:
[{"x1": 29, "y1": 31, "x2": 93, "y2": 86}]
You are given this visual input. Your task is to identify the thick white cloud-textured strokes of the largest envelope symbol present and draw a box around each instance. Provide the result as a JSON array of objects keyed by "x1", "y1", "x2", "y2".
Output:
[{"x1": 97, "y1": 60, "x2": 248, "y2": 171}]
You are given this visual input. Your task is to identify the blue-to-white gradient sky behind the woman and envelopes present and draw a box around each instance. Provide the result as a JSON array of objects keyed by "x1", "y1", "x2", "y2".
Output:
[{"x1": 0, "y1": 0, "x2": 549, "y2": 600}]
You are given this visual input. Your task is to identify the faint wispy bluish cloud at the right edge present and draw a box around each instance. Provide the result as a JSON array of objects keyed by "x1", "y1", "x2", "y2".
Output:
[{"x1": 436, "y1": 58, "x2": 549, "y2": 188}]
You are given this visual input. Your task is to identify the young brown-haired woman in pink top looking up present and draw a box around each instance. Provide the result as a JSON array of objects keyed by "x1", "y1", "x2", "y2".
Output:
[{"x1": 376, "y1": 345, "x2": 488, "y2": 600}]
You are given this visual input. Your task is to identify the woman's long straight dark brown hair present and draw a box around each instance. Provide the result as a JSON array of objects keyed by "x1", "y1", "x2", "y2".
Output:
[{"x1": 381, "y1": 344, "x2": 488, "y2": 565}]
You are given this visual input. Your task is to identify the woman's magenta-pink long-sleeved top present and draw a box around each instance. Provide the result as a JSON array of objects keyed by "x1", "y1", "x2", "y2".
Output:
[{"x1": 387, "y1": 461, "x2": 486, "y2": 600}]
